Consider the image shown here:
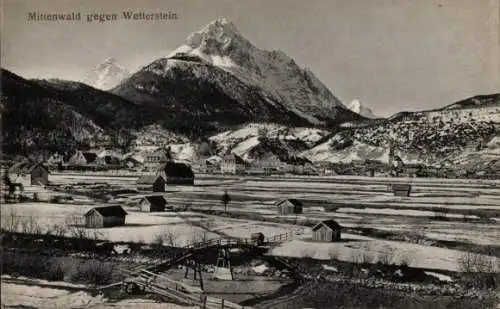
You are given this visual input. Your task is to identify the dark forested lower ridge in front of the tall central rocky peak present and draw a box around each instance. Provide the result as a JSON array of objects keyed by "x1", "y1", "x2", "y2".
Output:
[{"x1": 113, "y1": 58, "x2": 307, "y2": 125}]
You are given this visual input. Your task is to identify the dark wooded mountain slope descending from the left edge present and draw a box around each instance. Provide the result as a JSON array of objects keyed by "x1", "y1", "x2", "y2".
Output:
[{"x1": 1, "y1": 69, "x2": 103, "y2": 153}]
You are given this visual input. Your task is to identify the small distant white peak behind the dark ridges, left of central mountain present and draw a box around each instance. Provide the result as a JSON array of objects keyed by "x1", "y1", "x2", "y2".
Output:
[{"x1": 84, "y1": 57, "x2": 131, "y2": 90}]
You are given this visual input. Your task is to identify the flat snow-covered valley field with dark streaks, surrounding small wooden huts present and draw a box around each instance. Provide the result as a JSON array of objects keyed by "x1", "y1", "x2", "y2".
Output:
[{"x1": 2, "y1": 175, "x2": 500, "y2": 270}]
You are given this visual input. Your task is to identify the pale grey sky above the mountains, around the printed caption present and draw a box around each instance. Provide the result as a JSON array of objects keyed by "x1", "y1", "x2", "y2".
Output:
[{"x1": 1, "y1": 0, "x2": 500, "y2": 116}]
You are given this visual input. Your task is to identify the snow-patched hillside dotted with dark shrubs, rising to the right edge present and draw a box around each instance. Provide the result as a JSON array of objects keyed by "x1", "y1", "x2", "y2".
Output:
[{"x1": 304, "y1": 94, "x2": 500, "y2": 167}]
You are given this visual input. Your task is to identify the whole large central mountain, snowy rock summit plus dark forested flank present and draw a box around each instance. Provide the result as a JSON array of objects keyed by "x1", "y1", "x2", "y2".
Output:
[{"x1": 112, "y1": 19, "x2": 363, "y2": 125}]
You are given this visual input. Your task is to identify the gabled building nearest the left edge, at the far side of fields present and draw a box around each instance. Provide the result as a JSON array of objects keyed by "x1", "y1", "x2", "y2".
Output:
[{"x1": 7, "y1": 161, "x2": 49, "y2": 186}]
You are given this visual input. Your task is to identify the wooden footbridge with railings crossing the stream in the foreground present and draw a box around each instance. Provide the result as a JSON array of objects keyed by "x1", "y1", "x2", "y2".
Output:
[{"x1": 113, "y1": 231, "x2": 293, "y2": 309}]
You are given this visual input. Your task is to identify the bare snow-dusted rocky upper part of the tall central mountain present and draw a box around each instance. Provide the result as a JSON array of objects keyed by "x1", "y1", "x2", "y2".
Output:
[{"x1": 162, "y1": 18, "x2": 345, "y2": 124}]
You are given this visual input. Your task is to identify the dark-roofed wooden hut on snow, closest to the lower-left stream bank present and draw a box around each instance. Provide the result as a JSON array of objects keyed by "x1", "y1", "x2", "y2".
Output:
[{"x1": 85, "y1": 206, "x2": 127, "y2": 228}]
